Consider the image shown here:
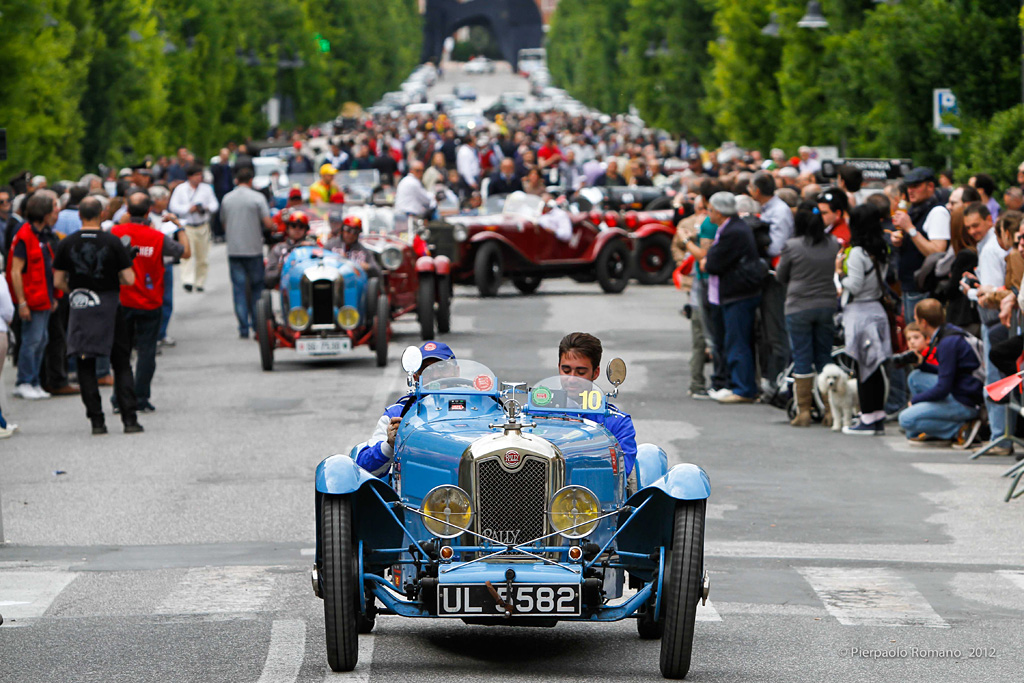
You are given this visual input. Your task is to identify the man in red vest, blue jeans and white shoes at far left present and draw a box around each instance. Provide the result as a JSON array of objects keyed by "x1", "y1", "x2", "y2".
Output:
[{"x1": 7, "y1": 190, "x2": 60, "y2": 399}]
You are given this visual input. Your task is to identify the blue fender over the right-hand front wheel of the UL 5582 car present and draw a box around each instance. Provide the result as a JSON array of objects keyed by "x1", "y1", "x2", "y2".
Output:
[{"x1": 616, "y1": 455, "x2": 711, "y2": 581}]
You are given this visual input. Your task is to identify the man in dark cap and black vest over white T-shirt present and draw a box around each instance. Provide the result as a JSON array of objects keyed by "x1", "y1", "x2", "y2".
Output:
[{"x1": 892, "y1": 166, "x2": 949, "y2": 321}]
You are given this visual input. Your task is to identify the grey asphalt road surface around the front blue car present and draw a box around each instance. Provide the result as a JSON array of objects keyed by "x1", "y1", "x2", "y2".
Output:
[{"x1": 0, "y1": 61, "x2": 1024, "y2": 683}]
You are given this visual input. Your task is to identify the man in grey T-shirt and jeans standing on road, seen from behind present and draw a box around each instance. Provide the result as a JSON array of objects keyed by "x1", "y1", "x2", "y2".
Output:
[{"x1": 220, "y1": 167, "x2": 273, "y2": 339}]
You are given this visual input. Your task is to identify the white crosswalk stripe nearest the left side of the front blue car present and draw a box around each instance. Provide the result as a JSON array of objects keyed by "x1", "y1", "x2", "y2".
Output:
[{"x1": 156, "y1": 566, "x2": 279, "y2": 614}]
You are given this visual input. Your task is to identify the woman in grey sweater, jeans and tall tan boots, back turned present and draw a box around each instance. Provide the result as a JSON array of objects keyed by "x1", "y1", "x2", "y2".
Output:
[{"x1": 775, "y1": 202, "x2": 839, "y2": 427}]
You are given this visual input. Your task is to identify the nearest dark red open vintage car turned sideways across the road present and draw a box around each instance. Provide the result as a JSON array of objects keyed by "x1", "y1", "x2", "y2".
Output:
[{"x1": 419, "y1": 193, "x2": 633, "y2": 297}]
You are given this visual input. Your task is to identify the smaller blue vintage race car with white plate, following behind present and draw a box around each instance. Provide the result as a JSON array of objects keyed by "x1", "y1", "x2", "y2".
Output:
[{"x1": 256, "y1": 245, "x2": 389, "y2": 371}]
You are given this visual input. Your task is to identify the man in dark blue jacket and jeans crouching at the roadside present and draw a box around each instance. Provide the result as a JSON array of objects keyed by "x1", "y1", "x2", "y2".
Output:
[{"x1": 899, "y1": 299, "x2": 982, "y2": 441}]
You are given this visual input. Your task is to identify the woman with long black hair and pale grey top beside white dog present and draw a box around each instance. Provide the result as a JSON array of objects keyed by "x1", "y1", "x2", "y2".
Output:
[{"x1": 836, "y1": 204, "x2": 892, "y2": 436}]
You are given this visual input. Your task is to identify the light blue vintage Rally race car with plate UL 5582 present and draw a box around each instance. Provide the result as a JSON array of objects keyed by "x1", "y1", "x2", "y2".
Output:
[{"x1": 312, "y1": 347, "x2": 711, "y2": 678}]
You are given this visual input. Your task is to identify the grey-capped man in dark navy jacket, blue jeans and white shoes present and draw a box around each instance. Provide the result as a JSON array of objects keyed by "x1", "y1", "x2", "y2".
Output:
[{"x1": 701, "y1": 191, "x2": 768, "y2": 403}]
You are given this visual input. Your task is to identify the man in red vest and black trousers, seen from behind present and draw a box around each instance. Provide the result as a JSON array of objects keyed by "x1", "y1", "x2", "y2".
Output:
[{"x1": 111, "y1": 193, "x2": 184, "y2": 413}]
